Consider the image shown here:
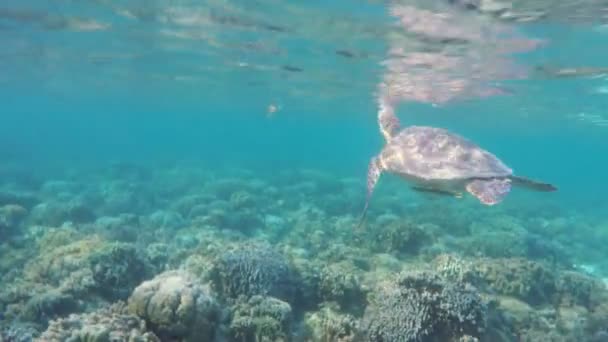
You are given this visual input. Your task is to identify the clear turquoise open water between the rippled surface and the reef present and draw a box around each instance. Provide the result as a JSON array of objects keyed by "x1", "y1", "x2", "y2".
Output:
[{"x1": 0, "y1": 2, "x2": 608, "y2": 218}]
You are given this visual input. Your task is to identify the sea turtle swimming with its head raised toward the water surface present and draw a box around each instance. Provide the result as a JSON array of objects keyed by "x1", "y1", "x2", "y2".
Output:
[{"x1": 359, "y1": 102, "x2": 557, "y2": 225}]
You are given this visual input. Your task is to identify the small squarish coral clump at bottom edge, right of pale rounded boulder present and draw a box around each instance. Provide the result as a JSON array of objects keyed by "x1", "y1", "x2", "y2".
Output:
[{"x1": 229, "y1": 296, "x2": 292, "y2": 342}]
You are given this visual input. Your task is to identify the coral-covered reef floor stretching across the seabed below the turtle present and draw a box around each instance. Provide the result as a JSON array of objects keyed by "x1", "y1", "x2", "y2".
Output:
[{"x1": 0, "y1": 163, "x2": 608, "y2": 342}]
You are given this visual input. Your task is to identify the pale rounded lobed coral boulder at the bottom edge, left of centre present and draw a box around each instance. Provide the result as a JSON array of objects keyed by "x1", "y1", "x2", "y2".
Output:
[{"x1": 129, "y1": 271, "x2": 220, "y2": 342}]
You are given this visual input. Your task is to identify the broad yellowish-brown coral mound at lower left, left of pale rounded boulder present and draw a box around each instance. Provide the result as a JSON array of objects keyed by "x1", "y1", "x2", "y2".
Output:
[{"x1": 15, "y1": 235, "x2": 147, "y2": 322}]
